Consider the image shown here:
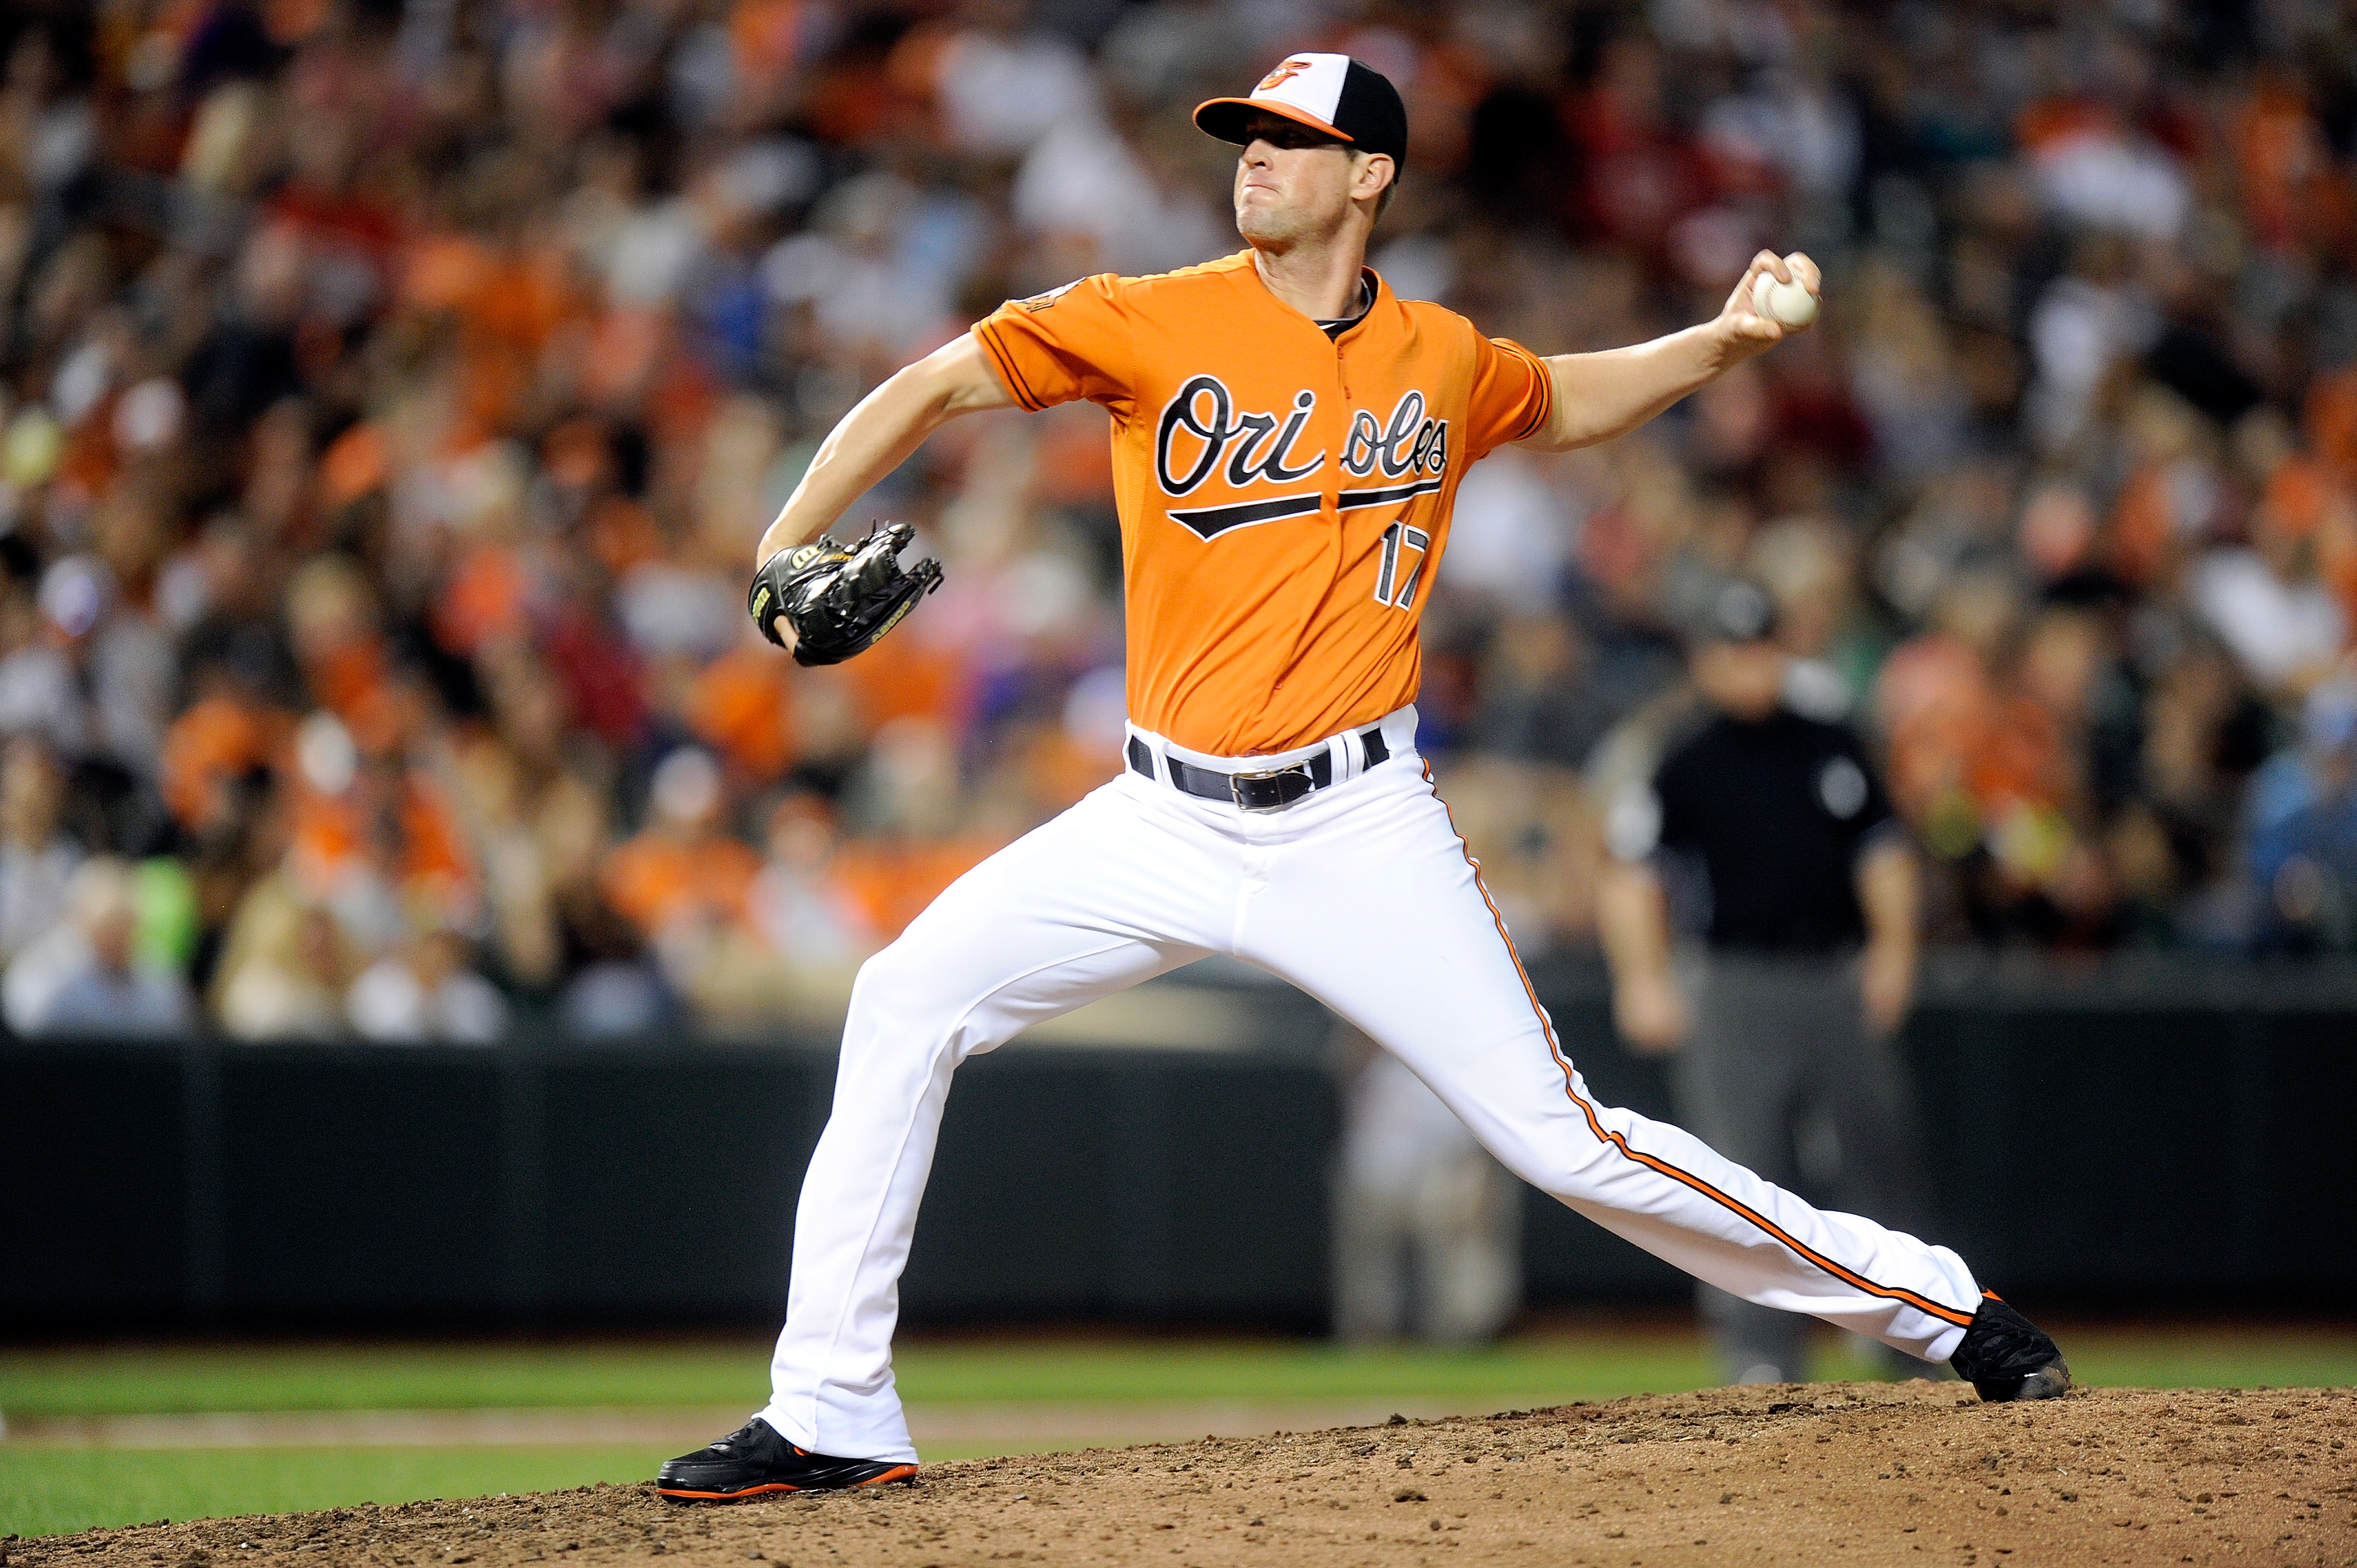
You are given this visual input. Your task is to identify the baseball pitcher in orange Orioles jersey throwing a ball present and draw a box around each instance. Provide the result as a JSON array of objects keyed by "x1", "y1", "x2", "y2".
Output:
[{"x1": 657, "y1": 54, "x2": 2070, "y2": 1499}]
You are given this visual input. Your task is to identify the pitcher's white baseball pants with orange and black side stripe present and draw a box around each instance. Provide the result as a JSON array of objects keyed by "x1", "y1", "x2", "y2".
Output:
[{"x1": 761, "y1": 708, "x2": 1980, "y2": 1459}]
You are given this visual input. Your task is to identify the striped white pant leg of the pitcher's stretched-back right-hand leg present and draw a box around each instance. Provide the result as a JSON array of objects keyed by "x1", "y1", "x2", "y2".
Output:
[{"x1": 1240, "y1": 757, "x2": 1982, "y2": 1360}]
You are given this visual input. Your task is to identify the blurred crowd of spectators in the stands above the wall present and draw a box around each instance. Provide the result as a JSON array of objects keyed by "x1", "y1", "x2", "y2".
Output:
[{"x1": 0, "y1": 0, "x2": 2357, "y2": 1040}]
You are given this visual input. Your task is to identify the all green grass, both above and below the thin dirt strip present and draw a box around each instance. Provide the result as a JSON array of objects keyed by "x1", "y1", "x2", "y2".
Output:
[{"x1": 0, "y1": 1325, "x2": 2357, "y2": 1535}]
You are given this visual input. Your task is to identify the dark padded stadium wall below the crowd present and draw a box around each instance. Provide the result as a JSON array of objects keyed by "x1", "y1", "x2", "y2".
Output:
[{"x1": 0, "y1": 964, "x2": 2357, "y2": 1334}]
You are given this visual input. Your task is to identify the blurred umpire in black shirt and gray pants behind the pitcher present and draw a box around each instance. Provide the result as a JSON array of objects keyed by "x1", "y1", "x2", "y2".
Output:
[{"x1": 1598, "y1": 580, "x2": 1921, "y2": 1382}]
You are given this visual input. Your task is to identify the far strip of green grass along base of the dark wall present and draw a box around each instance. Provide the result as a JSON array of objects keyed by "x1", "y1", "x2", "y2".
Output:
[{"x1": 0, "y1": 1328, "x2": 2357, "y2": 1417}]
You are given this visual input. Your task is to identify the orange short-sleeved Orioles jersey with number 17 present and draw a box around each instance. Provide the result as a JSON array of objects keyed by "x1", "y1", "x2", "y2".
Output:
[{"x1": 974, "y1": 250, "x2": 1553, "y2": 757}]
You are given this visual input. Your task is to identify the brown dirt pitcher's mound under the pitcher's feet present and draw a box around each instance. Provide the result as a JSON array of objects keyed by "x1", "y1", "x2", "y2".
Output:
[{"x1": 23, "y1": 1382, "x2": 2357, "y2": 1568}]
